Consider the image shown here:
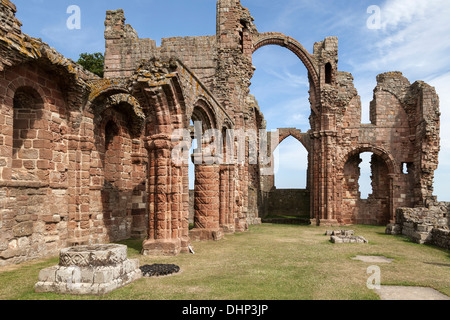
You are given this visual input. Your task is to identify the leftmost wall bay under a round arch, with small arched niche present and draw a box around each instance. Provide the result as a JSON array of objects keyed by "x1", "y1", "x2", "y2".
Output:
[{"x1": 0, "y1": 64, "x2": 70, "y2": 264}]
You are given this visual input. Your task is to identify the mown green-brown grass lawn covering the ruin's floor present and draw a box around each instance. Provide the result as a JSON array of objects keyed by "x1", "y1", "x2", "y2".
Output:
[{"x1": 0, "y1": 224, "x2": 450, "y2": 300}]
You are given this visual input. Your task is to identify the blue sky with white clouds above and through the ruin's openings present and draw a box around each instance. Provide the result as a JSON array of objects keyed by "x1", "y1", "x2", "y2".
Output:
[{"x1": 13, "y1": 0, "x2": 450, "y2": 201}]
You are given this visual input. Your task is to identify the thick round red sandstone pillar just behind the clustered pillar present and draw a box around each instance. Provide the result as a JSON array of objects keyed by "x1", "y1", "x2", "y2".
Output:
[{"x1": 190, "y1": 158, "x2": 223, "y2": 241}]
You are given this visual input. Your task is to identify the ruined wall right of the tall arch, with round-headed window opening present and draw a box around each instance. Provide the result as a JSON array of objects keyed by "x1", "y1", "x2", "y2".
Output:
[{"x1": 336, "y1": 72, "x2": 439, "y2": 224}]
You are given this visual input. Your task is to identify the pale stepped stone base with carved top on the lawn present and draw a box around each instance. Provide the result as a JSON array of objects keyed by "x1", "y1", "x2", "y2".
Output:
[{"x1": 35, "y1": 244, "x2": 142, "y2": 295}]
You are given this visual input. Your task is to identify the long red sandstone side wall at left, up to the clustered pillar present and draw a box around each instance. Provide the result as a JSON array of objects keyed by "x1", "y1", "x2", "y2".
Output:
[{"x1": 0, "y1": 1, "x2": 153, "y2": 265}]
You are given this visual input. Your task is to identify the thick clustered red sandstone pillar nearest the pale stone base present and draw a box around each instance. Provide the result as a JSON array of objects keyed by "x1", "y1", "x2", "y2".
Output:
[{"x1": 142, "y1": 135, "x2": 189, "y2": 255}]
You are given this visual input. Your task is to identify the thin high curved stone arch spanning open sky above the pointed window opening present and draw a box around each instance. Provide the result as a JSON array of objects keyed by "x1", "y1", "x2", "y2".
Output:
[{"x1": 253, "y1": 32, "x2": 320, "y2": 114}]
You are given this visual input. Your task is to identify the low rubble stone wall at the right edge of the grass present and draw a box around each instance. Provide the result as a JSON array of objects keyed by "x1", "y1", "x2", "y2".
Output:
[{"x1": 386, "y1": 202, "x2": 450, "y2": 249}]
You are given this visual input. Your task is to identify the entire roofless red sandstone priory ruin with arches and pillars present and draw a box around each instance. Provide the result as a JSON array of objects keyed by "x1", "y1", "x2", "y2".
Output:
[{"x1": 0, "y1": 0, "x2": 440, "y2": 266}]
